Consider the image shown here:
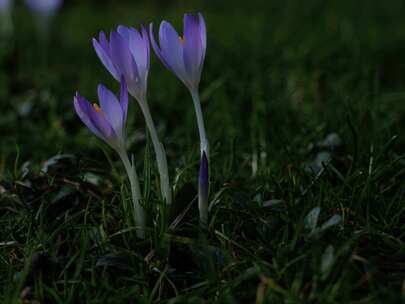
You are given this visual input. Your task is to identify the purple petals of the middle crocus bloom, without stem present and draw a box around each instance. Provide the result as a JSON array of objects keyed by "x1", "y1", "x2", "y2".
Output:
[{"x1": 93, "y1": 26, "x2": 150, "y2": 103}]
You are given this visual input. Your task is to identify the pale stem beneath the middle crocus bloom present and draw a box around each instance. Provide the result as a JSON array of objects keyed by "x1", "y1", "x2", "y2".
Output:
[{"x1": 139, "y1": 100, "x2": 172, "y2": 205}]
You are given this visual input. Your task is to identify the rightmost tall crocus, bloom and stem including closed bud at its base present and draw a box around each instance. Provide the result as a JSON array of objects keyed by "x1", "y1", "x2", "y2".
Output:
[{"x1": 149, "y1": 14, "x2": 209, "y2": 228}]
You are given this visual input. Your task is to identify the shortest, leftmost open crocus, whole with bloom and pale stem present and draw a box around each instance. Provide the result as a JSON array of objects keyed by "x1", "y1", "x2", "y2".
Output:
[{"x1": 74, "y1": 79, "x2": 145, "y2": 238}]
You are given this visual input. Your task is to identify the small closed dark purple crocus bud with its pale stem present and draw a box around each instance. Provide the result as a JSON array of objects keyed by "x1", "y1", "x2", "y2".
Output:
[{"x1": 198, "y1": 152, "x2": 209, "y2": 226}]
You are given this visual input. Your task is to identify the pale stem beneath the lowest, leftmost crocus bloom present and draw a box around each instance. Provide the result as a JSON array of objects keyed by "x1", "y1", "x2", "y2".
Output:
[{"x1": 118, "y1": 149, "x2": 145, "y2": 239}]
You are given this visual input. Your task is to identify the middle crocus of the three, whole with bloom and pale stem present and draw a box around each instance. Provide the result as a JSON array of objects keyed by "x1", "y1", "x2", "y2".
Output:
[{"x1": 93, "y1": 26, "x2": 172, "y2": 204}]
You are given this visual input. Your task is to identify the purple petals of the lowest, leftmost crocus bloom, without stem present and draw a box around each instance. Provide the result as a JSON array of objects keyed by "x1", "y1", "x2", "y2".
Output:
[{"x1": 74, "y1": 80, "x2": 128, "y2": 153}]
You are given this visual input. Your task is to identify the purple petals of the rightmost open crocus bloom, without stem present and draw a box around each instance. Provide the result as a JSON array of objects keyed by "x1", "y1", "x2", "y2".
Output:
[{"x1": 149, "y1": 13, "x2": 207, "y2": 90}]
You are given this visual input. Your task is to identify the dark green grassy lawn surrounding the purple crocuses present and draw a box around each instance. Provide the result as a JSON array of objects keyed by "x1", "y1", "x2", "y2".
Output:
[{"x1": 0, "y1": 0, "x2": 405, "y2": 304}]
